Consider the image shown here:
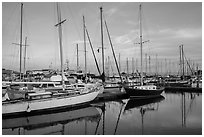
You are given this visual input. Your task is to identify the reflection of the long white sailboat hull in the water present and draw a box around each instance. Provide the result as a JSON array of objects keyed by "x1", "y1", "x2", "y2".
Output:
[{"x1": 2, "y1": 106, "x2": 101, "y2": 130}]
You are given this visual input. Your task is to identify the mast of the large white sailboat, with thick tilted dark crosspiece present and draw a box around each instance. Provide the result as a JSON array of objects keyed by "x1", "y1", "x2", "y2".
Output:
[{"x1": 55, "y1": 3, "x2": 66, "y2": 90}]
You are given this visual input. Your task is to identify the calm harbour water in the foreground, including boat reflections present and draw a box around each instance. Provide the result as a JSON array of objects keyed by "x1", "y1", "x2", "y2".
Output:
[{"x1": 2, "y1": 92, "x2": 202, "y2": 135}]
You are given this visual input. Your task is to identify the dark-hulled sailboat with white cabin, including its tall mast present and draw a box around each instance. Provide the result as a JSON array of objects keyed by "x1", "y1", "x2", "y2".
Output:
[{"x1": 124, "y1": 4, "x2": 164, "y2": 98}]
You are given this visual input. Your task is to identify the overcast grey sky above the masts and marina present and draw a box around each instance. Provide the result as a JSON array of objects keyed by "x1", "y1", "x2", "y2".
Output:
[{"x1": 2, "y1": 2, "x2": 202, "y2": 75}]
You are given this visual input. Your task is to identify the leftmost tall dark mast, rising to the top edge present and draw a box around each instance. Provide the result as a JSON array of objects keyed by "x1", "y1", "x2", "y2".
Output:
[{"x1": 20, "y1": 3, "x2": 23, "y2": 81}]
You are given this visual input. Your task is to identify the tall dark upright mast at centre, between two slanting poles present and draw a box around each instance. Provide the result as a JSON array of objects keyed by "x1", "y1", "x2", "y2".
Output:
[{"x1": 100, "y1": 7, "x2": 105, "y2": 82}]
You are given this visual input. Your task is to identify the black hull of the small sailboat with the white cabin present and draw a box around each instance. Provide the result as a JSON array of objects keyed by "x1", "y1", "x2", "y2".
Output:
[{"x1": 124, "y1": 87, "x2": 164, "y2": 98}]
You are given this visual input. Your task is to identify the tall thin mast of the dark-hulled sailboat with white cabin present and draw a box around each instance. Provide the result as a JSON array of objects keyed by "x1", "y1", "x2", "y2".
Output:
[{"x1": 139, "y1": 4, "x2": 143, "y2": 86}]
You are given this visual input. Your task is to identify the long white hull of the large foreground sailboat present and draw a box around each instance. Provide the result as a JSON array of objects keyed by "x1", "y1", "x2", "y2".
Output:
[{"x1": 2, "y1": 86, "x2": 102, "y2": 115}]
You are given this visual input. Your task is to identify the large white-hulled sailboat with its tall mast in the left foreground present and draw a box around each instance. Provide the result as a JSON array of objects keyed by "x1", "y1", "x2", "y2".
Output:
[{"x1": 2, "y1": 3, "x2": 103, "y2": 117}]
